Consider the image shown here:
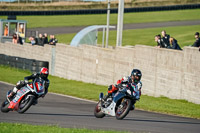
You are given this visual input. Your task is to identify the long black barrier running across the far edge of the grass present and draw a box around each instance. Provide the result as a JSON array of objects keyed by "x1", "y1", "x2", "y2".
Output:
[{"x1": 0, "y1": 4, "x2": 200, "y2": 16}]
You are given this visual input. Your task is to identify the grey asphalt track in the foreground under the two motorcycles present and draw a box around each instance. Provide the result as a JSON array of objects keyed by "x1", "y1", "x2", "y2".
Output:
[{"x1": 0, "y1": 82, "x2": 200, "y2": 133}]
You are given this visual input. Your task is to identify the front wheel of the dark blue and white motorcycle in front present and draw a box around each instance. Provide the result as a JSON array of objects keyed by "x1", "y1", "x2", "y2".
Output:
[{"x1": 115, "y1": 99, "x2": 131, "y2": 120}]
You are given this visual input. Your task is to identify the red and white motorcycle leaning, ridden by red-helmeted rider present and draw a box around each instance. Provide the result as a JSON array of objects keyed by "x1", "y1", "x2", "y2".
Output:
[{"x1": 1, "y1": 79, "x2": 45, "y2": 113}]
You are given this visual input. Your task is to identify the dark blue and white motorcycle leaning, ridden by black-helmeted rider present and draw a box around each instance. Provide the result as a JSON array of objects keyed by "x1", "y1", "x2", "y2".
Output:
[{"x1": 94, "y1": 87, "x2": 135, "y2": 120}]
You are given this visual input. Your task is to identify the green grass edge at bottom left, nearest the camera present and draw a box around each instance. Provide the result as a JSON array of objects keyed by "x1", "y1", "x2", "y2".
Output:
[{"x1": 0, "y1": 123, "x2": 128, "y2": 133}]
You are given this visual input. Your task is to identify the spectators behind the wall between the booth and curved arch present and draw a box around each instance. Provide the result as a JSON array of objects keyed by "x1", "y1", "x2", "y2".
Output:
[{"x1": 29, "y1": 33, "x2": 58, "y2": 46}]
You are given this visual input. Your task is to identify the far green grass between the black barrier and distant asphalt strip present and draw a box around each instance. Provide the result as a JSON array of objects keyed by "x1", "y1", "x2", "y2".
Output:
[{"x1": 0, "y1": 9, "x2": 200, "y2": 28}]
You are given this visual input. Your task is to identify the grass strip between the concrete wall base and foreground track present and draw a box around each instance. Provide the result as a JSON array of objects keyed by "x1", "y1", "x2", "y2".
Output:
[{"x1": 0, "y1": 66, "x2": 200, "y2": 119}]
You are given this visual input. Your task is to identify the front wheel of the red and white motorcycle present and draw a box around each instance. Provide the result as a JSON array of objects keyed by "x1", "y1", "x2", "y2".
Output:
[{"x1": 17, "y1": 95, "x2": 35, "y2": 114}]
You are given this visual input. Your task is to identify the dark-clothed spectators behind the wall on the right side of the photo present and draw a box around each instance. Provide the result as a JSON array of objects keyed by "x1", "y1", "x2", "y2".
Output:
[{"x1": 155, "y1": 30, "x2": 200, "y2": 51}]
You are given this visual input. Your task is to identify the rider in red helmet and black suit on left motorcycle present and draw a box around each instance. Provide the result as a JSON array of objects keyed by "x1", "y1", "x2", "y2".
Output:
[{"x1": 8, "y1": 67, "x2": 50, "y2": 99}]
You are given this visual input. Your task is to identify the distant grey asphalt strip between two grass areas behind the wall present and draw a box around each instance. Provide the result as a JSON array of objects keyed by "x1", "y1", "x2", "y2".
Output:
[{"x1": 28, "y1": 20, "x2": 200, "y2": 35}]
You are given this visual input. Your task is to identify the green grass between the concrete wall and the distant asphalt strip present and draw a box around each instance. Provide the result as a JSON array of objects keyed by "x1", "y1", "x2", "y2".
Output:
[{"x1": 56, "y1": 25, "x2": 200, "y2": 47}]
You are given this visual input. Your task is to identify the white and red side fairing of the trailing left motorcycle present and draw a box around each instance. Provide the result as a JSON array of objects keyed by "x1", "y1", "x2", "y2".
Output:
[{"x1": 8, "y1": 86, "x2": 30, "y2": 110}]
